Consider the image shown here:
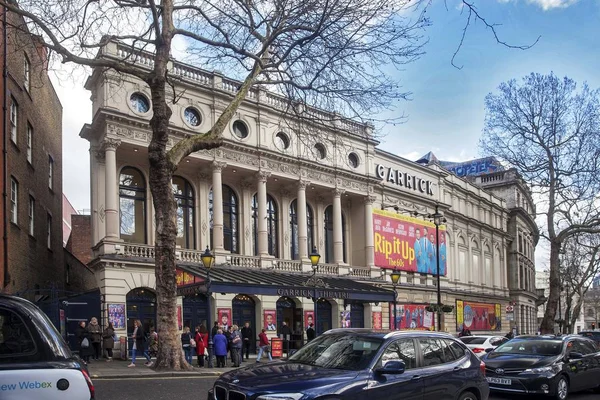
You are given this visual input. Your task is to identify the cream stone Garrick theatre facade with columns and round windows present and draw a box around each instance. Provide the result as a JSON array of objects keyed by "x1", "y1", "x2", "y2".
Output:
[{"x1": 81, "y1": 43, "x2": 536, "y2": 345}]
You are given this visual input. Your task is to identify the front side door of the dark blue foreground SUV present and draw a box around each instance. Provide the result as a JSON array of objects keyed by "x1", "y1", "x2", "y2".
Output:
[{"x1": 365, "y1": 338, "x2": 423, "y2": 400}]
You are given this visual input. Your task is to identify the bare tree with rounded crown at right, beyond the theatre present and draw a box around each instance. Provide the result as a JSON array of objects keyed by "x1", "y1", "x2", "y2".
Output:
[{"x1": 480, "y1": 73, "x2": 600, "y2": 333}]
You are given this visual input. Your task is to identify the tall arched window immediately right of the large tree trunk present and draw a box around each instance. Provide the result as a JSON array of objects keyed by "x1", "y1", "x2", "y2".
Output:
[{"x1": 173, "y1": 176, "x2": 196, "y2": 249}]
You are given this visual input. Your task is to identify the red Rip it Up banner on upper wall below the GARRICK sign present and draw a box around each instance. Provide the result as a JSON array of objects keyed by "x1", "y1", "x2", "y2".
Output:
[{"x1": 373, "y1": 210, "x2": 447, "y2": 275}]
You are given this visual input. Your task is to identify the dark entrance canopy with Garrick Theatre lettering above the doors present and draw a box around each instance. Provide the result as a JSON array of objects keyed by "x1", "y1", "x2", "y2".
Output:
[{"x1": 177, "y1": 264, "x2": 394, "y2": 303}]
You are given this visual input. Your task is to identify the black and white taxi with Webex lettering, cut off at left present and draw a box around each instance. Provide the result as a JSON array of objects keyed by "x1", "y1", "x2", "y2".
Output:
[{"x1": 0, "y1": 294, "x2": 95, "y2": 400}]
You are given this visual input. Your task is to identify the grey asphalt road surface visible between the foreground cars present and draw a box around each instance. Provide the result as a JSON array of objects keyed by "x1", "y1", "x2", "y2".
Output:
[{"x1": 94, "y1": 377, "x2": 598, "y2": 400}]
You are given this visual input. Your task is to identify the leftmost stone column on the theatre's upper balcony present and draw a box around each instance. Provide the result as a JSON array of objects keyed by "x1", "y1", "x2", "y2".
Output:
[{"x1": 102, "y1": 139, "x2": 121, "y2": 240}]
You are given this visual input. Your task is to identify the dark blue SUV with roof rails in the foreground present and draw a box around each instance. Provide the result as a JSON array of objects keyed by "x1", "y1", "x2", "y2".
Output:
[{"x1": 208, "y1": 328, "x2": 489, "y2": 400}]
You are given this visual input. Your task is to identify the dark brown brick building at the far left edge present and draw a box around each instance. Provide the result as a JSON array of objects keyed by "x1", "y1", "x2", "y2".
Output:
[{"x1": 0, "y1": 10, "x2": 64, "y2": 298}]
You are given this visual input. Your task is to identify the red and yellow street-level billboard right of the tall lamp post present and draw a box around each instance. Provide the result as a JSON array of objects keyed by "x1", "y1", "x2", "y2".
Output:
[{"x1": 456, "y1": 300, "x2": 502, "y2": 332}]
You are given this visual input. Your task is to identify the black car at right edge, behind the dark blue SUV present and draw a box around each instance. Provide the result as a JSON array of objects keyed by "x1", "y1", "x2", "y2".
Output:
[{"x1": 483, "y1": 335, "x2": 600, "y2": 400}]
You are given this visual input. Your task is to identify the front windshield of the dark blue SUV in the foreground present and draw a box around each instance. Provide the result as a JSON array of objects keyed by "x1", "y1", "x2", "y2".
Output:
[{"x1": 290, "y1": 334, "x2": 383, "y2": 371}]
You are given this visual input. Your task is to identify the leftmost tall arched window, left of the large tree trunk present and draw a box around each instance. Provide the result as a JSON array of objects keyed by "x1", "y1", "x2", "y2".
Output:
[{"x1": 119, "y1": 167, "x2": 146, "y2": 243}]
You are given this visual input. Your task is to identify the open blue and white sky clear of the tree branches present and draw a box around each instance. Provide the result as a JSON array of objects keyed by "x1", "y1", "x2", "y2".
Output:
[{"x1": 52, "y1": 0, "x2": 600, "y2": 268}]
